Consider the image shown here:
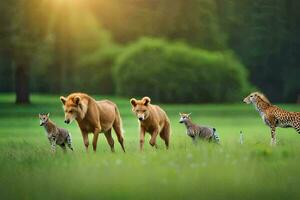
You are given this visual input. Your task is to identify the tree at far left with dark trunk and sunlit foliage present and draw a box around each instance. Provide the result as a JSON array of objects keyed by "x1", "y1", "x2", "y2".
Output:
[{"x1": 0, "y1": 0, "x2": 46, "y2": 103}]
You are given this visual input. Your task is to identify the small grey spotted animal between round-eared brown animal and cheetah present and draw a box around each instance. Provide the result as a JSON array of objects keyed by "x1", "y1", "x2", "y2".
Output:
[{"x1": 179, "y1": 113, "x2": 220, "y2": 143}]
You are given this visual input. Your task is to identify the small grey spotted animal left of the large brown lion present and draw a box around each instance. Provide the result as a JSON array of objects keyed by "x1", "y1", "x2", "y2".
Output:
[{"x1": 39, "y1": 113, "x2": 73, "y2": 152}]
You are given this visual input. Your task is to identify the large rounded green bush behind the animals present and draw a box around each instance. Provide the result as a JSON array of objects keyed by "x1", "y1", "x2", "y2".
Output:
[{"x1": 114, "y1": 38, "x2": 250, "y2": 103}]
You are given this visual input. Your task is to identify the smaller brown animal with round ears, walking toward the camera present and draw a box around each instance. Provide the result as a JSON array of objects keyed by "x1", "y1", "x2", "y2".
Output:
[{"x1": 130, "y1": 97, "x2": 170, "y2": 150}]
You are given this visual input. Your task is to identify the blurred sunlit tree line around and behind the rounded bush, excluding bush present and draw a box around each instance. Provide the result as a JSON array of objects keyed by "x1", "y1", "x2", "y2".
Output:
[{"x1": 0, "y1": 0, "x2": 300, "y2": 103}]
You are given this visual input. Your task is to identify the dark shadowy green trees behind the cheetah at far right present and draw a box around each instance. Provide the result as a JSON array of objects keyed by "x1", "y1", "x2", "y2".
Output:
[{"x1": 218, "y1": 0, "x2": 300, "y2": 102}]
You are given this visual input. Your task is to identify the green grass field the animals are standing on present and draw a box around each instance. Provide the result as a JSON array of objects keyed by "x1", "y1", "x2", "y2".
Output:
[{"x1": 0, "y1": 95, "x2": 300, "y2": 200}]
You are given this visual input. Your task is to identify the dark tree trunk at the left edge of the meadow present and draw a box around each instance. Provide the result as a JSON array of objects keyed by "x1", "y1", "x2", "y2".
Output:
[{"x1": 15, "y1": 61, "x2": 30, "y2": 104}]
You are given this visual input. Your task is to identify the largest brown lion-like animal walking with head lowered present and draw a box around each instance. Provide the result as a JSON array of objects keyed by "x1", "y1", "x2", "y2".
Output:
[{"x1": 60, "y1": 93, "x2": 125, "y2": 152}]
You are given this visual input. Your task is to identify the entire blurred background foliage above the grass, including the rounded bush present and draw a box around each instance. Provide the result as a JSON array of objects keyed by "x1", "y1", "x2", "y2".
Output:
[{"x1": 0, "y1": 0, "x2": 300, "y2": 103}]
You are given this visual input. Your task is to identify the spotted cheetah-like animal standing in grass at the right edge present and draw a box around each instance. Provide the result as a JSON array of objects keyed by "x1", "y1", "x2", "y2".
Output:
[{"x1": 244, "y1": 92, "x2": 300, "y2": 145}]
